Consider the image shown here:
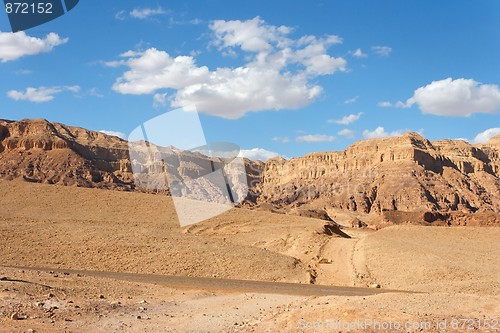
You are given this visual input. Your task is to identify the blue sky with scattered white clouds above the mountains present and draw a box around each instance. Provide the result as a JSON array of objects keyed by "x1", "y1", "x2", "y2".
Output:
[{"x1": 0, "y1": 0, "x2": 500, "y2": 160}]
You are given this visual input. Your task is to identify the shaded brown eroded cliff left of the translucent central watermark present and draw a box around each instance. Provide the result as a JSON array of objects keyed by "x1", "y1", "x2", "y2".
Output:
[{"x1": 0, "y1": 119, "x2": 133, "y2": 190}]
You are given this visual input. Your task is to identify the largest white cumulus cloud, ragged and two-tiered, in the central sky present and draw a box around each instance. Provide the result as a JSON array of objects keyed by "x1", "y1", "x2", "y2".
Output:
[{"x1": 112, "y1": 17, "x2": 347, "y2": 119}]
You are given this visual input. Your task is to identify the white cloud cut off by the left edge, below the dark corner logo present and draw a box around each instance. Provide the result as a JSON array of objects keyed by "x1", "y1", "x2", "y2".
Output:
[{"x1": 0, "y1": 31, "x2": 68, "y2": 62}]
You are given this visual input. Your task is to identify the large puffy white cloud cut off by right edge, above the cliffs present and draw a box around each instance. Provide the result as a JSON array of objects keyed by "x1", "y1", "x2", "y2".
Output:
[{"x1": 406, "y1": 78, "x2": 500, "y2": 117}]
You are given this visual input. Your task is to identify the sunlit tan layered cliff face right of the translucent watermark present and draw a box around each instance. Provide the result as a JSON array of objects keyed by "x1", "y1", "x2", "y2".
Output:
[{"x1": 258, "y1": 133, "x2": 500, "y2": 213}]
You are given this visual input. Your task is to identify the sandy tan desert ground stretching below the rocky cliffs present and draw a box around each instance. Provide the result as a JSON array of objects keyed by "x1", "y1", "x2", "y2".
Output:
[{"x1": 0, "y1": 181, "x2": 500, "y2": 332}]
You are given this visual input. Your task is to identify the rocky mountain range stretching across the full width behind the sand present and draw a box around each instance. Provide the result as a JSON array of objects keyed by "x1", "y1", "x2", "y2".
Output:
[{"x1": 0, "y1": 119, "x2": 500, "y2": 221}]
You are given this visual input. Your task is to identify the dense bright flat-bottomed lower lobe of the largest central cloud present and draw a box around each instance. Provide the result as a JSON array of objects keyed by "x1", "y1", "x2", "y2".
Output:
[{"x1": 172, "y1": 67, "x2": 322, "y2": 119}]
